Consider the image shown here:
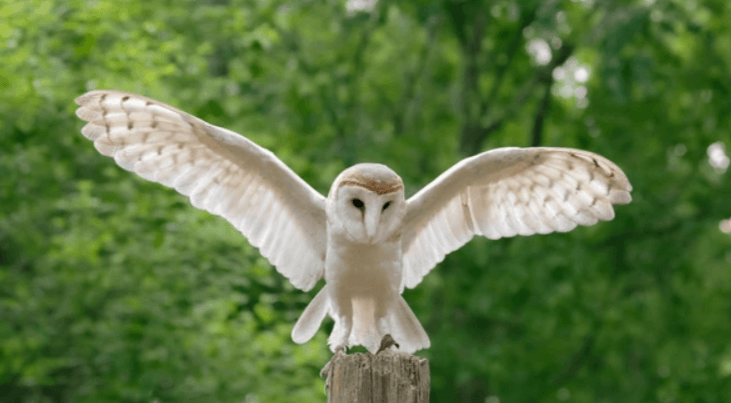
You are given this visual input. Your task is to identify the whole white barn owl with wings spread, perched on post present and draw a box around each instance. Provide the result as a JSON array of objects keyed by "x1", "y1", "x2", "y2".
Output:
[{"x1": 76, "y1": 91, "x2": 632, "y2": 360}]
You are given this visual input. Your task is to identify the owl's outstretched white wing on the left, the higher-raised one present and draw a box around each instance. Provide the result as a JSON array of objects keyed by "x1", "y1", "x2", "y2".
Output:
[{"x1": 76, "y1": 91, "x2": 326, "y2": 290}]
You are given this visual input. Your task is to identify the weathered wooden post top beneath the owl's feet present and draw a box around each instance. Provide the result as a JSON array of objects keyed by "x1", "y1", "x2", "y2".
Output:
[{"x1": 326, "y1": 351, "x2": 429, "y2": 403}]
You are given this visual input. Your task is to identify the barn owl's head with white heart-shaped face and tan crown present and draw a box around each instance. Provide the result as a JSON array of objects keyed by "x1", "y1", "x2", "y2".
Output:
[{"x1": 327, "y1": 164, "x2": 406, "y2": 244}]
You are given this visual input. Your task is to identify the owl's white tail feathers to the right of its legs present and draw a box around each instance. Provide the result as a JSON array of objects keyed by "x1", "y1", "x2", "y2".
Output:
[{"x1": 386, "y1": 295, "x2": 431, "y2": 354}]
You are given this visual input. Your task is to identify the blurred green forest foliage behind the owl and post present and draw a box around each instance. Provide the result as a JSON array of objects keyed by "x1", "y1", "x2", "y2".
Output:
[{"x1": 0, "y1": 0, "x2": 731, "y2": 403}]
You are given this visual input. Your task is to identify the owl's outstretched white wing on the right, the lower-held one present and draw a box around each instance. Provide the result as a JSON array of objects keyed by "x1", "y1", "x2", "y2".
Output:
[{"x1": 401, "y1": 147, "x2": 632, "y2": 289}]
